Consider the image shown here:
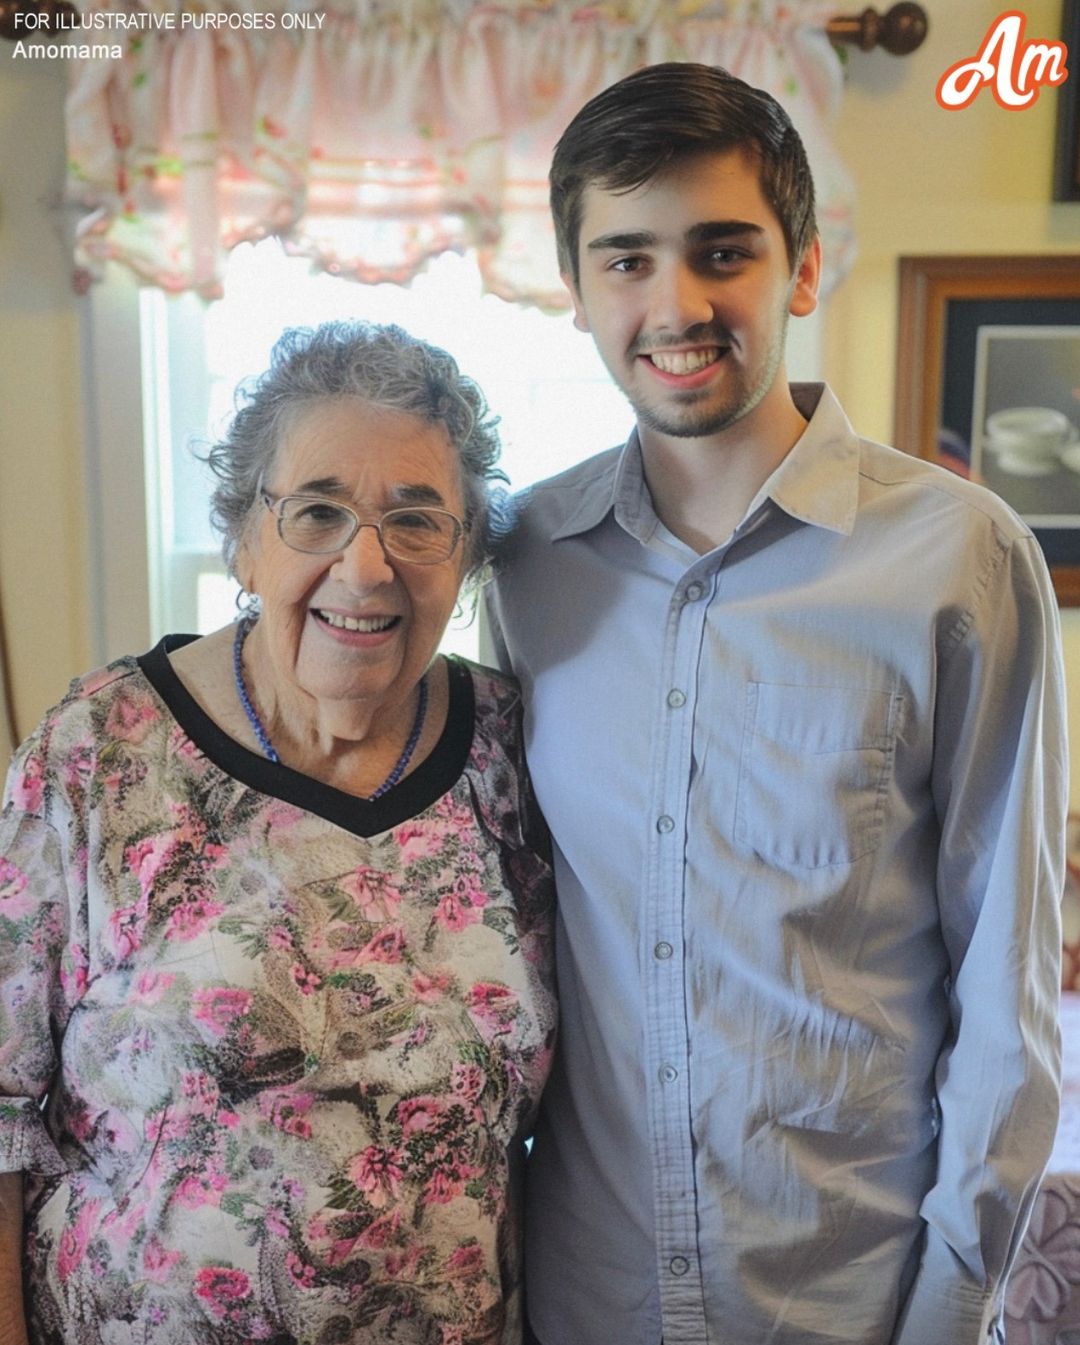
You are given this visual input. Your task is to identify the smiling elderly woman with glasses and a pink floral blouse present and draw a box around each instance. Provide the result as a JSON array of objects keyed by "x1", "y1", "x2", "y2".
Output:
[{"x1": 0, "y1": 324, "x2": 554, "y2": 1345}]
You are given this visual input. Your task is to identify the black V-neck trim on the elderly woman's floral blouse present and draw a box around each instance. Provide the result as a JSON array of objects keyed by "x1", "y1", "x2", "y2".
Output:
[{"x1": 136, "y1": 635, "x2": 476, "y2": 837}]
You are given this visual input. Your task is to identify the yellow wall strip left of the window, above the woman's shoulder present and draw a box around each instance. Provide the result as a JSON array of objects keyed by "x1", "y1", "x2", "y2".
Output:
[{"x1": 0, "y1": 57, "x2": 90, "y2": 733}]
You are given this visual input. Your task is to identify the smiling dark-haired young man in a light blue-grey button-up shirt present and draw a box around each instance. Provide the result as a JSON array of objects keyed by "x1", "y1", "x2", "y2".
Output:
[{"x1": 491, "y1": 65, "x2": 1067, "y2": 1345}]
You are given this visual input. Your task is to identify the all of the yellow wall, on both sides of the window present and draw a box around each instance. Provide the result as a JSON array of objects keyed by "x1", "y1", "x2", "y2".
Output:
[{"x1": 0, "y1": 0, "x2": 1080, "y2": 807}]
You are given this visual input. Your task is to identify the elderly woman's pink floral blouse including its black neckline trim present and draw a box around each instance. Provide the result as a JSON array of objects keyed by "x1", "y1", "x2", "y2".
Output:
[{"x1": 0, "y1": 638, "x2": 555, "y2": 1345}]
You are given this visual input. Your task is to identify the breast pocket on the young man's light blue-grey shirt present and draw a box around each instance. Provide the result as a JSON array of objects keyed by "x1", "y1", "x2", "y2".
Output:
[{"x1": 734, "y1": 682, "x2": 901, "y2": 869}]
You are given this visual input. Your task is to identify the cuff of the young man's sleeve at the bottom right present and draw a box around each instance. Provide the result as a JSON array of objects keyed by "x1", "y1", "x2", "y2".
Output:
[{"x1": 892, "y1": 1227, "x2": 1005, "y2": 1345}]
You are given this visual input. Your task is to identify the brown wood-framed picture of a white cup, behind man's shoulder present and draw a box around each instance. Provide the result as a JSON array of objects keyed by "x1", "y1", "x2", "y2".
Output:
[{"x1": 894, "y1": 252, "x2": 1080, "y2": 607}]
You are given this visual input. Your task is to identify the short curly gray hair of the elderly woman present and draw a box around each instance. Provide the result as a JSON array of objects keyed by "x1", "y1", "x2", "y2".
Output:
[{"x1": 206, "y1": 321, "x2": 510, "y2": 584}]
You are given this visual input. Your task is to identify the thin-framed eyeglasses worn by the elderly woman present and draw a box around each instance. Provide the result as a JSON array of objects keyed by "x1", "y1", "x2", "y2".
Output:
[{"x1": 261, "y1": 491, "x2": 465, "y2": 565}]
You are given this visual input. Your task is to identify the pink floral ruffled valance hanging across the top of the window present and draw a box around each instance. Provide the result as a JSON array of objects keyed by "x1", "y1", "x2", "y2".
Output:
[{"x1": 65, "y1": 0, "x2": 853, "y2": 308}]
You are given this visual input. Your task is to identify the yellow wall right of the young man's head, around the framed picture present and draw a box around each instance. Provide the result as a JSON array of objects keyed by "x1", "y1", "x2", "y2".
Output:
[{"x1": 826, "y1": 0, "x2": 1080, "y2": 808}]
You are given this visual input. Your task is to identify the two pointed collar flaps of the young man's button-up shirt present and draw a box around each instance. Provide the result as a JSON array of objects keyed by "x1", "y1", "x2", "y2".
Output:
[{"x1": 553, "y1": 383, "x2": 859, "y2": 541}]
